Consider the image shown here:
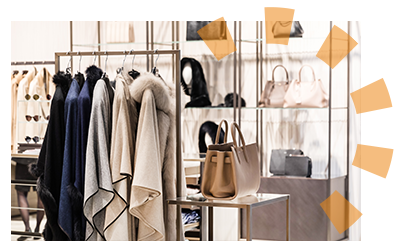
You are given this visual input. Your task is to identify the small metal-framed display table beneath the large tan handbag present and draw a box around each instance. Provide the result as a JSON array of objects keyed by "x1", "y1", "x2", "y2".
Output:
[{"x1": 167, "y1": 193, "x2": 290, "y2": 241}]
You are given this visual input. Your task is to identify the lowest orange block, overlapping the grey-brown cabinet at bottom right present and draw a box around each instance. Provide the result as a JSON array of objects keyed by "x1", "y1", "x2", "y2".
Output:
[{"x1": 320, "y1": 191, "x2": 363, "y2": 234}]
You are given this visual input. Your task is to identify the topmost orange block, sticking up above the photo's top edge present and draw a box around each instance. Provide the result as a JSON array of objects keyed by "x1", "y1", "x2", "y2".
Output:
[{"x1": 264, "y1": 7, "x2": 295, "y2": 45}]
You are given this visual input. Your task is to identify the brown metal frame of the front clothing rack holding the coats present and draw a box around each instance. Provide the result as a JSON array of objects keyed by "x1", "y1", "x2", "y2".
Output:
[{"x1": 55, "y1": 49, "x2": 183, "y2": 241}]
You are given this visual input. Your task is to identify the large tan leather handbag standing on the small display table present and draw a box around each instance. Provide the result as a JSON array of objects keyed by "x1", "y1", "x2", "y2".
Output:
[{"x1": 201, "y1": 120, "x2": 261, "y2": 200}]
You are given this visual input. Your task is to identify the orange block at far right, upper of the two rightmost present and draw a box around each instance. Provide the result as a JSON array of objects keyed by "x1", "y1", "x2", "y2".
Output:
[{"x1": 350, "y1": 77, "x2": 393, "y2": 114}]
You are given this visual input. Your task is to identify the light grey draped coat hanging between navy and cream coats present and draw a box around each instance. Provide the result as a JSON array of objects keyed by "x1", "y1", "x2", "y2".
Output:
[{"x1": 83, "y1": 79, "x2": 114, "y2": 241}]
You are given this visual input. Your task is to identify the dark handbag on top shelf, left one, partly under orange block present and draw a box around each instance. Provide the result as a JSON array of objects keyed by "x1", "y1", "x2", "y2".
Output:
[{"x1": 186, "y1": 21, "x2": 226, "y2": 41}]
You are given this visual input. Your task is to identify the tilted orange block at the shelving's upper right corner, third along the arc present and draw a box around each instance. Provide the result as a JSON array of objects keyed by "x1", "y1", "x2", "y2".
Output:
[{"x1": 317, "y1": 25, "x2": 358, "y2": 69}]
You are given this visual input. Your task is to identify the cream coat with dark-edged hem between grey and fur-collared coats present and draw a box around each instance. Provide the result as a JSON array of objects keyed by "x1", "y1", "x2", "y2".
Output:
[{"x1": 104, "y1": 70, "x2": 139, "y2": 241}]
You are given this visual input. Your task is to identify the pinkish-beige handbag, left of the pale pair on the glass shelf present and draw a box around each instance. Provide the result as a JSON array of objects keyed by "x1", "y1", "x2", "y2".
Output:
[{"x1": 258, "y1": 65, "x2": 289, "y2": 108}]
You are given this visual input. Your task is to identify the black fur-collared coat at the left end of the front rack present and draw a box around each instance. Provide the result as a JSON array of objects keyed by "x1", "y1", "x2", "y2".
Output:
[{"x1": 30, "y1": 72, "x2": 72, "y2": 241}]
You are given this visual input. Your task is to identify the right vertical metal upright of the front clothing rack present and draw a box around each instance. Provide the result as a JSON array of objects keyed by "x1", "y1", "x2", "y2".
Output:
[{"x1": 175, "y1": 50, "x2": 183, "y2": 241}]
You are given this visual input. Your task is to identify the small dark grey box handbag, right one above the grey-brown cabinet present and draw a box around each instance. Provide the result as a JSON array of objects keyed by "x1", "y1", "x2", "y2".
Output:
[{"x1": 285, "y1": 155, "x2": 312, "y2": 177}]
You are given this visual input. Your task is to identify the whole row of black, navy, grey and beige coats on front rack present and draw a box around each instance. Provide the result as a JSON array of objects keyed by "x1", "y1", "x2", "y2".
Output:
[{"x1": 27, "y1": 60, "x2": 186, "y2": 241}]
